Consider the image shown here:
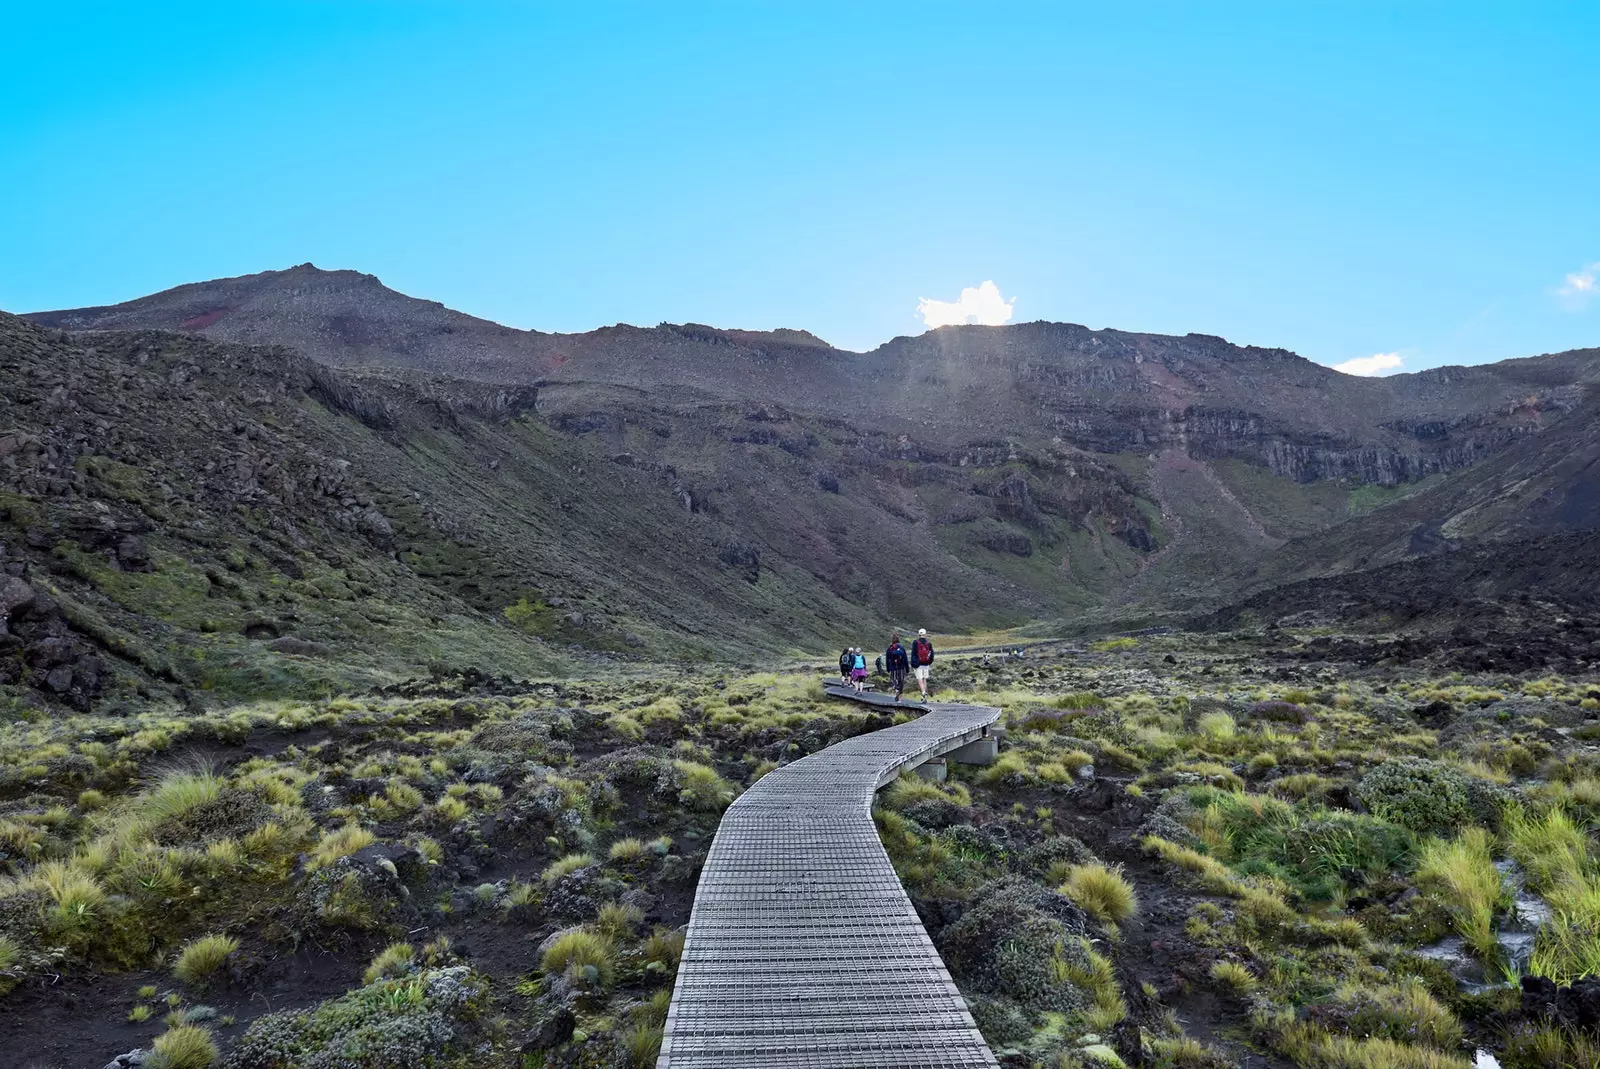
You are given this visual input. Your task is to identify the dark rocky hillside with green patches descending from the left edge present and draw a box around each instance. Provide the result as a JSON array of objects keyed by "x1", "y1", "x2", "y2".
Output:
[{"x1": 0, "y1": 314, "x2": 934, "y2": 706}]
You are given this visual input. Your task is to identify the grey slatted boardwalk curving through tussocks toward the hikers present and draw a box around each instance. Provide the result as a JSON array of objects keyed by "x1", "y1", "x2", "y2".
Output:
[{"x1": 656, "y1": 684, "x2": 1000, "y2": 1069}]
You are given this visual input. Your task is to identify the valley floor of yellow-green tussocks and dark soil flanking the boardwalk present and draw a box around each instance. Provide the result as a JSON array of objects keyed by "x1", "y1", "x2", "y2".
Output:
[{"x1": 0, "y1": 632, "x2": 1600, "y2": 1069}]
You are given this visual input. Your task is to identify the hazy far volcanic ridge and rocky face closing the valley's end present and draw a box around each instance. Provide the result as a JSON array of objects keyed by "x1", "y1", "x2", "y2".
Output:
[{"x1": 21, "y1": 264, "x2": 1600, "y2": 640}]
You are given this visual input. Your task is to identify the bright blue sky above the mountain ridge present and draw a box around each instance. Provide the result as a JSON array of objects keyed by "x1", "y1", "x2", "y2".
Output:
[{"x1": 0, "y1": 0, "x2": 1600, "y2": 370}]
